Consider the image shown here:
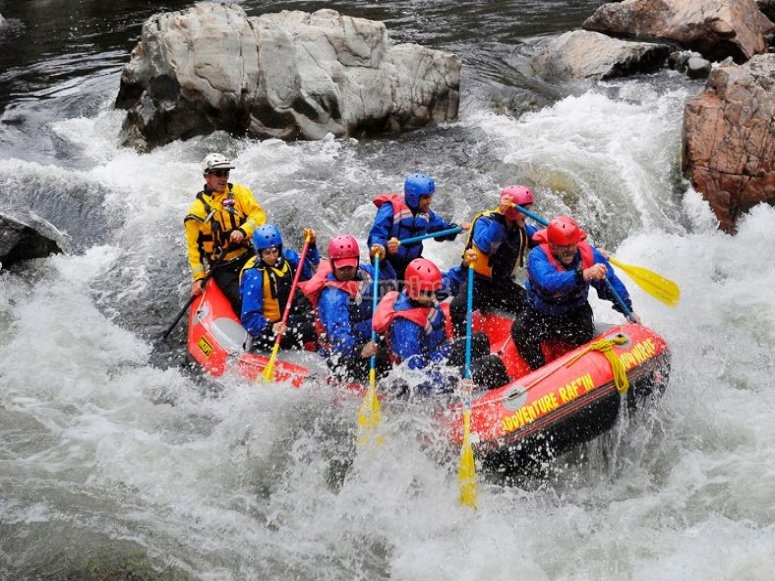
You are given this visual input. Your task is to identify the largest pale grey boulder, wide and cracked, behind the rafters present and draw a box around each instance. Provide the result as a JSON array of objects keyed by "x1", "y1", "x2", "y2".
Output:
[{"x1": 116, "y1": 3, "x2": 461, "y2": 149}]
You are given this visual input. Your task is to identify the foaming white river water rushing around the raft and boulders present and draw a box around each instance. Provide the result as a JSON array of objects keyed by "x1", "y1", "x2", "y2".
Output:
[{"x1": 0, "y1": 0, "x2": 775, "y2": 581}]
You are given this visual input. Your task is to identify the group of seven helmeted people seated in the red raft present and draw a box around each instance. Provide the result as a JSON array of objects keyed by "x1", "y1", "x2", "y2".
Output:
[{"x1": 184, "y1": 153, "x2": 639, "y2": 393}]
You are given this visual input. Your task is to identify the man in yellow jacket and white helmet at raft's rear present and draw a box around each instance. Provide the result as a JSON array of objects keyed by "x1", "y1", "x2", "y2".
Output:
[{"x1": 183, "y1": 153, "x2": 266, "y2": 316}]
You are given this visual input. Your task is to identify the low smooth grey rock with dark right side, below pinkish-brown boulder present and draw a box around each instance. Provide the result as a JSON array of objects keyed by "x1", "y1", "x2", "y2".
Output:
[{"x1": 531, "y1": 30, "x2": 672, "y2": 80}]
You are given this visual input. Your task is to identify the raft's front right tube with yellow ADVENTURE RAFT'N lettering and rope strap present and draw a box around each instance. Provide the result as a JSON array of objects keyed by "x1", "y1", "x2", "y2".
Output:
[{"x1": 441, "y1": 323, "x2": 670, "y2": 462}]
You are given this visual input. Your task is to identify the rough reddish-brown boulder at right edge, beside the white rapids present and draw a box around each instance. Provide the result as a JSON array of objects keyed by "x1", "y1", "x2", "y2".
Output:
[{"x1": 683, "y1": 54, "x2": 775, "y2": 232}]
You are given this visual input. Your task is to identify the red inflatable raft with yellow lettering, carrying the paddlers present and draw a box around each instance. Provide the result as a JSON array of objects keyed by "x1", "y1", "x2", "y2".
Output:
[{"x1": 188, "y1": 274, "x2": 670, "y2": 470}]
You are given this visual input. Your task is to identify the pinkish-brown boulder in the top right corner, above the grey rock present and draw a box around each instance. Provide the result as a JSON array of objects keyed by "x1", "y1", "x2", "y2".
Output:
[{"x1": 583, "y1": 0, "x2": 775, "y2": 63}]
